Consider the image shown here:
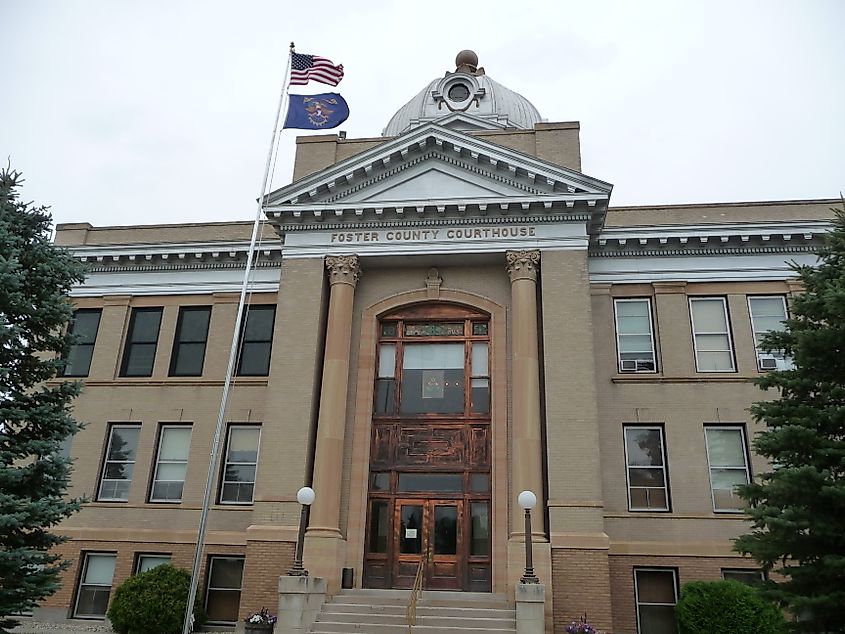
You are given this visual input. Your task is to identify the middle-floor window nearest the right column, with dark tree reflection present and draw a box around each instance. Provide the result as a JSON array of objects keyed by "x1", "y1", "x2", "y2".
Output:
[{"x1": 625, "y1": 427, "x2": 669, "y2": 511}]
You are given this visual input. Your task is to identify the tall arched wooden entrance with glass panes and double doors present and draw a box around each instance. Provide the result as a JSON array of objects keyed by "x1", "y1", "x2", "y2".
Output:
[{"x1": 364, "y1": 303, "x2": 492, "y2": 591}]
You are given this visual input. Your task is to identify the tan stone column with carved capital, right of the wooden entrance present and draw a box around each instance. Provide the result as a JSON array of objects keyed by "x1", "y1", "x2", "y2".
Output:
[{"x1": 505, "y1": 250, "x2": 545, "y2": 540}]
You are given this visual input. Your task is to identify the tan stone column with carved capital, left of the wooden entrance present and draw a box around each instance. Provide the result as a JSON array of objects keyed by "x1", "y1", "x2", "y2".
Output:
[{"x1": 305, "y1": 255, "x2": 360, "y2": 592}]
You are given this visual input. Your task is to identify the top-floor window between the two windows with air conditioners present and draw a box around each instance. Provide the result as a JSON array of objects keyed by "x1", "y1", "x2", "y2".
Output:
[{"x1": 689, "y1": 297, "x2": 734, "y2": 372}]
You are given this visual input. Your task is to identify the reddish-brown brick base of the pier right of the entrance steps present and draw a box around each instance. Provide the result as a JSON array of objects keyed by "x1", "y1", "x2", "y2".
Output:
[{"x1": 551, "y1": 548, "x2": 613, "y2": 634}]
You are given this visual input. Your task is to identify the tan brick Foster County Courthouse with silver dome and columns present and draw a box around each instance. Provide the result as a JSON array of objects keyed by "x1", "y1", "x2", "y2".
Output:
[{"x1": 42, "y1": 52, "x2": 833, "y2": 634}]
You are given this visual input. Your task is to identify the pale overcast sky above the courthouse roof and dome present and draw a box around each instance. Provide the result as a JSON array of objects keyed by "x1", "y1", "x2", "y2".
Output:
[{"x1": 0, "y1": 0, "x2": 845, "y2": 225}]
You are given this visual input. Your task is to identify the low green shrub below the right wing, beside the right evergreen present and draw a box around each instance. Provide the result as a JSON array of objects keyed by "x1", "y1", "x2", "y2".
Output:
[{"x1": 675, "y1": 581, "x2": 786, "y2": 634}]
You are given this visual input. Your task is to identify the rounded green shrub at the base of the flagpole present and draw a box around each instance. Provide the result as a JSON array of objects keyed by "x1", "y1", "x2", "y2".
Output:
[{"x1": 108, "y1": 565, "x2": 205, "y2": 634}]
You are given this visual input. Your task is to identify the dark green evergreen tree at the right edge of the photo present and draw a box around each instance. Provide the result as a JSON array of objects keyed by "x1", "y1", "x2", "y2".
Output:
[{"x1": 734, "y1": 201, "x2": 845, "y2": 632}]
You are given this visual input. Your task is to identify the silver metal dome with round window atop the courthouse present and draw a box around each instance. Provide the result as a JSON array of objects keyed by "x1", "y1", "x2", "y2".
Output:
[{"x1": 382, "y1": 52, "x2": 542, "y2": 136}]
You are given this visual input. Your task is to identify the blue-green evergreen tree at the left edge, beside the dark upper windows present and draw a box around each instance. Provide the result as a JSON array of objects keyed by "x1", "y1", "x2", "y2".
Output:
[{"x1": 0, "y1": 168, "x2": 84, "y2": 631}]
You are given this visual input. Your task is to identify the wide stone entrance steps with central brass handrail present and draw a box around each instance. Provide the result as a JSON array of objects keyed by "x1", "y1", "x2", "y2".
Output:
[{"x1": 311, "y1": 590, "x2": 516, "y2": 634}]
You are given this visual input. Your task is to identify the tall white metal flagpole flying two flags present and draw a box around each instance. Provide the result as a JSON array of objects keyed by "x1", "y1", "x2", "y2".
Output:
[{"x1": 182, "y1": 42, "x2": 294, "y2": 634}]
